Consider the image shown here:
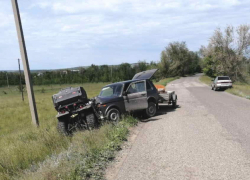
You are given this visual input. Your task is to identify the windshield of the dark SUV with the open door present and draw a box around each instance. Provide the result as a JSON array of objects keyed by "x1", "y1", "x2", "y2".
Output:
[{"x1": 99, "y1": 84, "x2": 122, "y2": 97}]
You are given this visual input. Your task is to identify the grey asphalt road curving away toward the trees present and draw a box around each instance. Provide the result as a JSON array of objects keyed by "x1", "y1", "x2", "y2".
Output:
[{"x1": 107, "y1": 75, "x2": 250, "y2": 180}]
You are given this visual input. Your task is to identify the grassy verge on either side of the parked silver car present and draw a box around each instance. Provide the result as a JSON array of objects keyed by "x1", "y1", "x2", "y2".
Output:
[{"x1": 200, "y1": 75, "x2": 250, "y2": 99}]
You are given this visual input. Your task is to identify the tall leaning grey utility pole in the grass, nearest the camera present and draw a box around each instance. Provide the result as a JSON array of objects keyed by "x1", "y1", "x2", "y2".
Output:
[{"x1": 11, "y1": 0, "x2": 39, "y2": 127}]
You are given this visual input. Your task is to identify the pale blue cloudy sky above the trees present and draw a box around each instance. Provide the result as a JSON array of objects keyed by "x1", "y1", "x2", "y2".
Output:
[{"x1": 0, "y1": 0, "x2": 250, "y2": 70}]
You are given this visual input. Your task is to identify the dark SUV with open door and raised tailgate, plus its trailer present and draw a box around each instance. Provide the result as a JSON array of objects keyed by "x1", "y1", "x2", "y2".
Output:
[{"x1": 95, "y1": 69, "x2": 177, "y2": 121}]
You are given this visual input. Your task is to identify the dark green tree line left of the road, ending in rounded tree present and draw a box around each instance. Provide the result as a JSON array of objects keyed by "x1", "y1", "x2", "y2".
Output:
[{"x1": 0, "y1": 42, "x2": 201, "y2": 86}]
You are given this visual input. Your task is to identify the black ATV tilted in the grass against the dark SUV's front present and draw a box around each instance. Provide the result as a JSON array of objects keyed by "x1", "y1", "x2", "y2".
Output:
[{"x1": 52, "y1": 87, "x2": 102, "y2": 135}]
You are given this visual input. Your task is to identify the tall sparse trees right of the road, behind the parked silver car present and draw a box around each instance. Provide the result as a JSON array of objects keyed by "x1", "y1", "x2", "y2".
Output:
[{"x1": 200, "y1": 25, "x2": 250, "y2": 83}]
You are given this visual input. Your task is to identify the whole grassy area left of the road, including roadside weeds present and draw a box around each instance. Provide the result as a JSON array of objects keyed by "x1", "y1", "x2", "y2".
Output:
[{"x1": 0, "y1": 77, "x2": 177, "y2": 180}]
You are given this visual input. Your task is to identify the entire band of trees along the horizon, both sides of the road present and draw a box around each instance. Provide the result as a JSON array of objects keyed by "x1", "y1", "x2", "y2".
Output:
[{"x1": 5, "y1": 25, "x2": 250, "y2": 86}]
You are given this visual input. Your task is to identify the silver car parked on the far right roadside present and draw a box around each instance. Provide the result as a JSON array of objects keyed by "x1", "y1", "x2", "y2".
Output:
[{"x1": 211, "y1": 76, "x2": 233, "y2": 91}]
